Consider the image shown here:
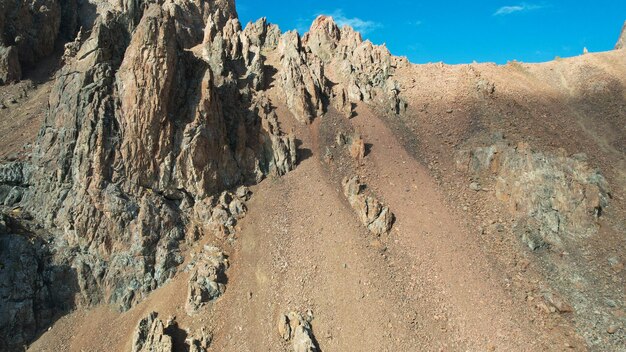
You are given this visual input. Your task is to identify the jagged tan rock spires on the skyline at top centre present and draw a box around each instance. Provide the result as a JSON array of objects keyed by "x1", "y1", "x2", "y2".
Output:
[{"x1": 278, "y1": 16, "x2": 408, "y2": 123}]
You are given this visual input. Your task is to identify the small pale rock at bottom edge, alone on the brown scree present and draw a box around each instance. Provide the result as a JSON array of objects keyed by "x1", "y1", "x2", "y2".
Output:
[{"x1": 278, "y1": 312, "x2": 319, "y2": 352}]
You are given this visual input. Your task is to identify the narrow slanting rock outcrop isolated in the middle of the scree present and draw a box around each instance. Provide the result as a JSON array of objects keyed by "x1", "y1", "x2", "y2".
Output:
[{"x1": 342, "y1": 176, "x2": 394, "y2": 236}]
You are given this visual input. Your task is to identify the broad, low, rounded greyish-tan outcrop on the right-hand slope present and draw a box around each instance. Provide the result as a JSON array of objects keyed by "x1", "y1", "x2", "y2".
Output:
[{"x1": 458, "y1": 142, "x2": 610, "y2": 250}]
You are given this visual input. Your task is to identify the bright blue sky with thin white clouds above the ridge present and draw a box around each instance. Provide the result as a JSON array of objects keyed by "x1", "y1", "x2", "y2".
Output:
[{"x1": 235, "y1": 0, "x2": 626, "y2": 64}]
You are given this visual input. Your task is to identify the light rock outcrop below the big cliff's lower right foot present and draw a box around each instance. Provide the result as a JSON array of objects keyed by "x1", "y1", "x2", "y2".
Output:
[{"x1": 185, "y1": 245, "x2": 229, "y2": 315}]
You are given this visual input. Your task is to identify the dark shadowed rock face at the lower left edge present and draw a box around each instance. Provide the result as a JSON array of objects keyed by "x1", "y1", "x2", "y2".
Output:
[{"x1": 0, "y1": 214, "x2": 78, "y2": 351}]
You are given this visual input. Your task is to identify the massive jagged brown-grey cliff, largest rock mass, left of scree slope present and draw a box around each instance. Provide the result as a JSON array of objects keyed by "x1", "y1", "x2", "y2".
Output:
[{"x1": 18, "y1": 0, "x2": 296, "y2": 310}]
